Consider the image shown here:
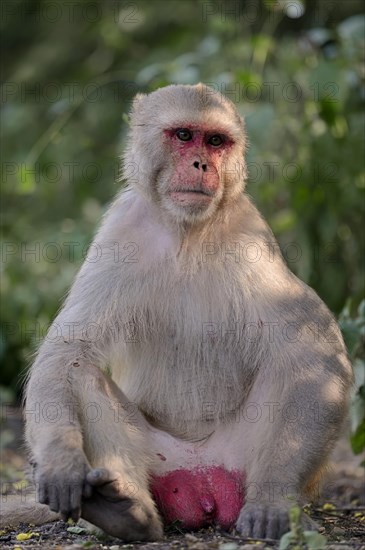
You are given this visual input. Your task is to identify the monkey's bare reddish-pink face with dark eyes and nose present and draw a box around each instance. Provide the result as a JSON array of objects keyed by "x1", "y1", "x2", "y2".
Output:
[{"x1": 164, "y1": 125, "x2": 233, "y2": 208}]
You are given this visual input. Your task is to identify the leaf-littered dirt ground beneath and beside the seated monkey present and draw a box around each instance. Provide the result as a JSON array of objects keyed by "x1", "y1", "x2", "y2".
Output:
[{"x1": 0, "y1": 409, "x2": 365, "y2": 550}]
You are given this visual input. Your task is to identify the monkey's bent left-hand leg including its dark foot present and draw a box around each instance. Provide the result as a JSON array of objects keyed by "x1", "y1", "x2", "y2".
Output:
[{"x1": 58, "y1": 366, "x2": 162, "y2": 541}]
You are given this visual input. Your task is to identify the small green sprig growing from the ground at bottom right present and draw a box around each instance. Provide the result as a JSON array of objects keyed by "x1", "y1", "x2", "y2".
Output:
[{"x1": 279, "y1": 506, "x2": 327, "y2": 550}]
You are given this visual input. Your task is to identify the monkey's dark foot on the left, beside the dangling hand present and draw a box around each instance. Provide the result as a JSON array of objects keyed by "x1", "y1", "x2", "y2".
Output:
[{"x1": 81, "y1": 468, "x2": 163, "y2": 542}]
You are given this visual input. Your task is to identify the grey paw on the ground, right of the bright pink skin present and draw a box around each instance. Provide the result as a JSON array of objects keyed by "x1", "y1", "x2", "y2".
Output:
[{"x1": 236, "y1": 502, "x2": 318, "y2": 539}]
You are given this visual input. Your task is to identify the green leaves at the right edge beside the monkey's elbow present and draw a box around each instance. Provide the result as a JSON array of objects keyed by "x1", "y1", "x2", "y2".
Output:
[{"x1": 339, "y1": 300, "x2": 365, "y2": 465}]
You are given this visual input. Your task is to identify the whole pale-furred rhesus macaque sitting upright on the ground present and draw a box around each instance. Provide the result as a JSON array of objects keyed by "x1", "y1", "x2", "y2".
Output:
[{"x1": 16, "y1": 84, "x2": 352, "y2": 541}]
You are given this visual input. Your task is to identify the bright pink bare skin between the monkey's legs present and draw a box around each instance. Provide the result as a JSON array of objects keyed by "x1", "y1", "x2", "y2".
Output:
[{"x1": 151, "y1": 466, "x2": 245, "y2": 529}]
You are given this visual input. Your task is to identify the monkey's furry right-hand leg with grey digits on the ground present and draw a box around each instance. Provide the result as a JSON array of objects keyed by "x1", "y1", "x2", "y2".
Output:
[{"x1": 233, "y1": 362, "x2": 346, "y2": 539}]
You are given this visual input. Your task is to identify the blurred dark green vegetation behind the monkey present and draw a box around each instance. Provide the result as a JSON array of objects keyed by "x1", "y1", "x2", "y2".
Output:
[{"x1": 0, "y1": 0, "x2": 365, "y2": 454}]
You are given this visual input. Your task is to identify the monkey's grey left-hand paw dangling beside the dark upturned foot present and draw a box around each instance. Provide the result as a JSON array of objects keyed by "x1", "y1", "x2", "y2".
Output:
[{"x1": 34, "y1": 447, "x2": 92, "y2": 521}]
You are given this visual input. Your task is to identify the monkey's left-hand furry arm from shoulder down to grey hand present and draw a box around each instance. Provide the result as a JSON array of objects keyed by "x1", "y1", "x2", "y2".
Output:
[{"x1": 25, "y1": 225, "x2": 128, "y2": 519}]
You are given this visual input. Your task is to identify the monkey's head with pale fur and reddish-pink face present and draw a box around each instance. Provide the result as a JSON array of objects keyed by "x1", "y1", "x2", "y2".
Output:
[{"x1": 124, "y1": 84, "x2": 246, "y2": 223}]
